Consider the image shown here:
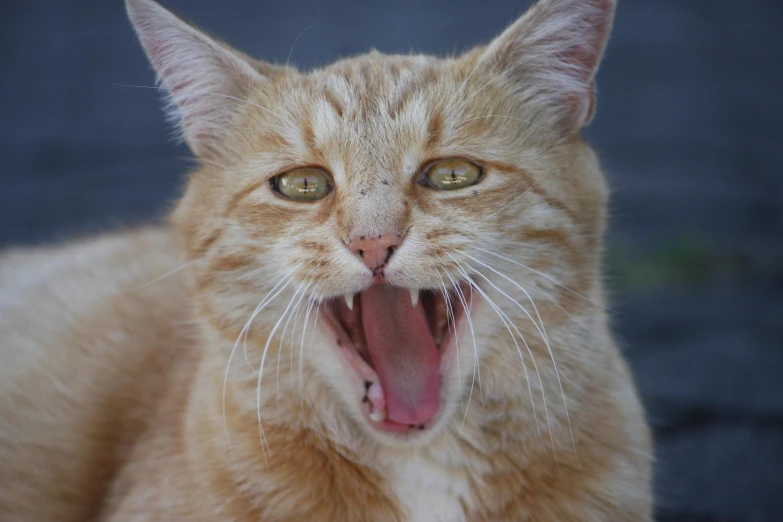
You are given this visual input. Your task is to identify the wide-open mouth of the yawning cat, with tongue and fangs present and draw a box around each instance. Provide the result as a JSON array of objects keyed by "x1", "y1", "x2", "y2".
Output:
[{"x1": 322, "y1": 284, "x2": 472, "y2": 433}]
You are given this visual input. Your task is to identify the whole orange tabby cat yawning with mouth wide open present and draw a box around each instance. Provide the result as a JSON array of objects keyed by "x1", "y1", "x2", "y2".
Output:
[{"x1": 0, "y1": 0, "x2": 652, "y2": 522}]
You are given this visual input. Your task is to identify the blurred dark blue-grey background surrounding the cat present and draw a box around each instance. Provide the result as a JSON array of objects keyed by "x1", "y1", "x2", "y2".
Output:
[{"x1": 0, "y1": 0, "x2": 783, "y2": 522}]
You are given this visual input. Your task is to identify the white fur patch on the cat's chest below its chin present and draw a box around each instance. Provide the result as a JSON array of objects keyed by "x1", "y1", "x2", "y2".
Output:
[{"x1": 386, "y1": 446, "x2": 473, "y2": 522}]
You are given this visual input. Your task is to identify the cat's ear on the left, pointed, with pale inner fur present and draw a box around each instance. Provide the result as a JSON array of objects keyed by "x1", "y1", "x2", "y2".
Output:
[{"x1": 126, "y1": 0, "x2": 265, "y2": 157}]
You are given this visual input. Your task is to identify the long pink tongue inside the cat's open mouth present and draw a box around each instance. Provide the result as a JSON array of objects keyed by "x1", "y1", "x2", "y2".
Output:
[{"x1": 359, "y1": 285, "x2": 440, "y2": 424}]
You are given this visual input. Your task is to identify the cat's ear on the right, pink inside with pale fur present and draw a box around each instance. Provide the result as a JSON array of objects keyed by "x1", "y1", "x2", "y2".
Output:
[{"x1": 477, "y1": 0, "x2": 617, "y2": 133}]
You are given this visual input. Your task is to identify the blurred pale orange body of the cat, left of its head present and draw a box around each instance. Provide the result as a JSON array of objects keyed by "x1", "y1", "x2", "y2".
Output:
[{"x1": 0, "y1": 228, "x2": 198, "y2": 521}]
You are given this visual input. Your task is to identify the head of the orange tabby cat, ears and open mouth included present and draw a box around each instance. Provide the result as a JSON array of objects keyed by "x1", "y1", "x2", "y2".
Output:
[{"x1": 128, "y1": 0, "x2": 614, "y2": 441}]
